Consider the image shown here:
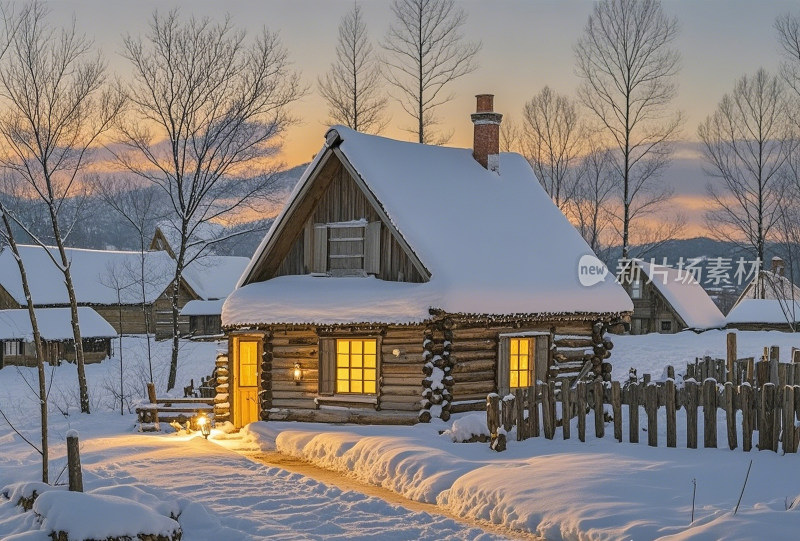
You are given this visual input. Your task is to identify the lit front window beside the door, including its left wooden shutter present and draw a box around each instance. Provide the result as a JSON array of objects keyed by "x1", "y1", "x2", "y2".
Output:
[{"x1": 319, "y1": 337, "x2": 380, "y2": 397}]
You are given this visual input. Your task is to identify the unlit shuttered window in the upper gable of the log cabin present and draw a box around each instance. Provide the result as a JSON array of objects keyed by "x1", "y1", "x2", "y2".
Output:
[{"x1": 306, "y1": 219, "x2": 381, "y2": 276}]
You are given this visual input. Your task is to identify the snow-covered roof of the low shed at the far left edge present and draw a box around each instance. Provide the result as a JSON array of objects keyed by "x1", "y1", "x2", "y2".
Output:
[{"x1": 0, "y1": 306, "x2": 117, "y2": 341}]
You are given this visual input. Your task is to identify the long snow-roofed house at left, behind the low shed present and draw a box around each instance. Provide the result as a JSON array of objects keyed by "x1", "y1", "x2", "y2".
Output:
[{"x1": 0, "y1": 245, "x2": 200, "y2": 338}]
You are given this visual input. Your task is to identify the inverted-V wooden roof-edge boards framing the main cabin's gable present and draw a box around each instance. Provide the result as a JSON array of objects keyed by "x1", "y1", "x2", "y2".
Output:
[{"x1": 237, "y1": 132, "x2": 430, "y2": 287}]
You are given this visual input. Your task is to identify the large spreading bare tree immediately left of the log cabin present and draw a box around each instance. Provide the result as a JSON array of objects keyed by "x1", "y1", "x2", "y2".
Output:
[{"x1": 113, "y1": 11, "x2": 305, "y2": 389}]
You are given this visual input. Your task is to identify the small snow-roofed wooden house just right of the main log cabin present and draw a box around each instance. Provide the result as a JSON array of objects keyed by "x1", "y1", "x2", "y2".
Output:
[{"x1": 620, "y1": 259, "x2": 725, "y2": 334}]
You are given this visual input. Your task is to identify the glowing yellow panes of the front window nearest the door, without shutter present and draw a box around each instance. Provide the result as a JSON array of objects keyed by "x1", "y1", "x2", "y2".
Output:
[{"x1": 336, "y1": 339, "x2": 378, "y2": 394}]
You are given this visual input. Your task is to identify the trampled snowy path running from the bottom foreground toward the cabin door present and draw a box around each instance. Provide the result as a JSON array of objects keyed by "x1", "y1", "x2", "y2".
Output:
[{"x1": 81, "y1": 435, "x2": 501, "y2": 541}]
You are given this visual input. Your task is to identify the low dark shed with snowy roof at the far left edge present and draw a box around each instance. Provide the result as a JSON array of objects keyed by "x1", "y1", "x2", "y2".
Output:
[{"x1": 0, "y1": 307, "x2": 117, "y2": 368}]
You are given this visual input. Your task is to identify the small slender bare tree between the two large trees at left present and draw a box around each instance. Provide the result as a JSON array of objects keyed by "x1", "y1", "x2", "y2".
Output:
[{"x1": 97, "y1": 177, "x2": 167, "y2": 382}]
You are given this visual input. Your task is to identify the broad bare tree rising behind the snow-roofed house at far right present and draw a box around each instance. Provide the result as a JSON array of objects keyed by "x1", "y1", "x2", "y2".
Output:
[{"x1": 697, "y1": 69, "x2": 794, "y2": 261}]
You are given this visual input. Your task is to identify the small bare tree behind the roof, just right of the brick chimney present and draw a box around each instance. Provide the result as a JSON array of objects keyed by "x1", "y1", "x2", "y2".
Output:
[{"x1": 523, "y1": 86, "x2": 584, "y2": 211}]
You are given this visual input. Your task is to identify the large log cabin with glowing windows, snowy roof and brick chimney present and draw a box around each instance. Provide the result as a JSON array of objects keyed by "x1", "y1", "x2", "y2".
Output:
[{"x1": 222, "y1": 95, "x2": 632, "y2": 426}]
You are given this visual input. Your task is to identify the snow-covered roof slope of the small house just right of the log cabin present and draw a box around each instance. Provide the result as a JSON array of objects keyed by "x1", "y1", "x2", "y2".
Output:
[{"x1": 635, "y1": 260, "x2": 725, "y2": 330}]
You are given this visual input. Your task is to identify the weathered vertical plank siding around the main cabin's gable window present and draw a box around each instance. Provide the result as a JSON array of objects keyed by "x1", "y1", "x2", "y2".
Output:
[{"x1": 275, "y1": 159, "x2": 425, "y2": 283}]
